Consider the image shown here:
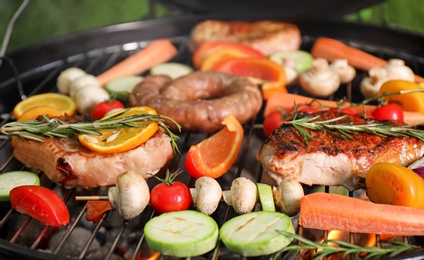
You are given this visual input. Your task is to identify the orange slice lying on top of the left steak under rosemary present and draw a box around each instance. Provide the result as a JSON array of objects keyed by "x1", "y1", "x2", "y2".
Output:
[{"x1": 78, "y1": 106, "x2": 159, "y2": 153}]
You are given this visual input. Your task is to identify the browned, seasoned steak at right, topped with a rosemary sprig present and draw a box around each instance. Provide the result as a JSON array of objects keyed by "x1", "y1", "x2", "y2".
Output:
[{"x1": 257, "y1": 112, "x2": 424, "y2": 190}]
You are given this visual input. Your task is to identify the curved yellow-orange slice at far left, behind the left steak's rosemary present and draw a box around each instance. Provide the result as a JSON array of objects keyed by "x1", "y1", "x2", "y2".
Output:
[{"x1": 13, "y1": 93, "x2": 77, "y2": 118}]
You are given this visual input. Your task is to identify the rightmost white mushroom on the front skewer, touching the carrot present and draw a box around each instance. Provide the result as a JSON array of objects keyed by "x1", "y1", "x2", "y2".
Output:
[{"x1": 273, "y1": 180, "x2": 305, "y2": 216}]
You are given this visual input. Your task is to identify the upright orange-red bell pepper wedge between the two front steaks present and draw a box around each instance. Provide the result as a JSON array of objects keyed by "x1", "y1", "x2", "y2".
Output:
[{"x1": 184, "y1": 115, "x2": 244, "y2": 178}]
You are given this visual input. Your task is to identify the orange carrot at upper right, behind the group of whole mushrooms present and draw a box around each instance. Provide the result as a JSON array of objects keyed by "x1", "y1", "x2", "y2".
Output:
[{"x1": 311, "y1": 37, "x2": 424, "y2": 82}]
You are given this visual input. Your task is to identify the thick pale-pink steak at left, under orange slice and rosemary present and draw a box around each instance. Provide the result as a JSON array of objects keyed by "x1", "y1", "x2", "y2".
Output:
[{"x1": 13, "y1": 130, "x2": 173, "y2": 188}]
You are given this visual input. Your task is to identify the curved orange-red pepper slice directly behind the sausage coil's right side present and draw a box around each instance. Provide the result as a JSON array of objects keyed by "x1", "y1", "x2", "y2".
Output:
[{"x1": 211, "y1": 58, "x2": 287, "y2": 100}]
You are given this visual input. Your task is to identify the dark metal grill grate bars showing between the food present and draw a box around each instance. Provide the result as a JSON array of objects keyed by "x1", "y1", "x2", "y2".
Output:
[{"x1": 0, "y1": 17, "x2": 424, "y2": 259}]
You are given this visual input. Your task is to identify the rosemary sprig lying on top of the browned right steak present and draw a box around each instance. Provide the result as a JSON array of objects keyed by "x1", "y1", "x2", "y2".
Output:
[{"x1": 284, "y1": 115, "x2": 424, "y2": 145}]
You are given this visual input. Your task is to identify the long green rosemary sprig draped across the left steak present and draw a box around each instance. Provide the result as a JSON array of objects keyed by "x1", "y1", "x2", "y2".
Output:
[{"x1": 1, "y1": 109, "x2": 181, "y2": 153}]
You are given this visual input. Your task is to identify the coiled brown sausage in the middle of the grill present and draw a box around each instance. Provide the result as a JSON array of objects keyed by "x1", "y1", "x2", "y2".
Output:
[{"x1": 129, "y1": 71, "x2": 262, "y2": 133}]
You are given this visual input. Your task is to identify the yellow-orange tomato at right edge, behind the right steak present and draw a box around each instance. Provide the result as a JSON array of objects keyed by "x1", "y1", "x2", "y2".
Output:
[{"x1": 378, "y1": 80, "x2": 424, "y2": 114}]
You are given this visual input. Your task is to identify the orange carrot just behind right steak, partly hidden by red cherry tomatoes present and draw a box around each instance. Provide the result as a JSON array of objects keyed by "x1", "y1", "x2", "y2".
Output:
[{"x1": 264, "y1": 93, "x2": 424, "y2": 124}]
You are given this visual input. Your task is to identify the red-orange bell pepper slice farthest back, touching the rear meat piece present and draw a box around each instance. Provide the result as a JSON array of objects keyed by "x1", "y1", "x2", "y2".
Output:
[{"x1": 193, "y1": 41, "x2": 266, "y2": 70}]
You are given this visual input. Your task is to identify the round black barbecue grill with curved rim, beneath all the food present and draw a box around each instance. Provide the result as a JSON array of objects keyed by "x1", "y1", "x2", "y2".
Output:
[{"x1": 0, "y1": 1, "x2": 424, "y2": 259}]
